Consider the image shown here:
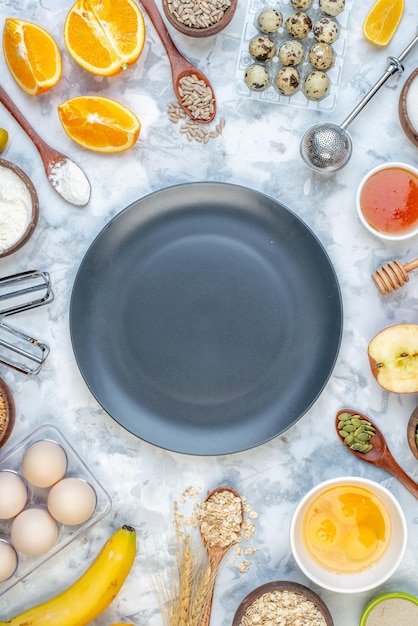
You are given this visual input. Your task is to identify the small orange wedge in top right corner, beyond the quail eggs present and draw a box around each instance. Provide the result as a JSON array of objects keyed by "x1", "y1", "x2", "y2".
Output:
[{"x1": 363, "y1": 0, "x2": 404, "y2": 46}]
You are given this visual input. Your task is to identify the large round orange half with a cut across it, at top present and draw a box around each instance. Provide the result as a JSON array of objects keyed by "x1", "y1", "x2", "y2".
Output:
[{"x1": 64, "y1": 0, "x2": 145, "y2": 76}]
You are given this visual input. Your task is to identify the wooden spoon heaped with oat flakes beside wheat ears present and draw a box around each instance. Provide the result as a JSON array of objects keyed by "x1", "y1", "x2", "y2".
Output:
[{"x1": 199, "y1": 487, "x2": 244, "y2": 626}]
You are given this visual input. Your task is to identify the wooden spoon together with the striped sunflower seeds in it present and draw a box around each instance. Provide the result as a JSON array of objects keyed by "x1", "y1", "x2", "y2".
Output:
[{"x1": 141, "y1": 0, "x2": 216, "y2": 124}]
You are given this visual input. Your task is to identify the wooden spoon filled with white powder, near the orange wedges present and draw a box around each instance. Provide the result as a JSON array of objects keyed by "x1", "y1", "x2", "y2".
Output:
[{"x1": 0, "y1": 85, "x2": 91, "y2": 206}]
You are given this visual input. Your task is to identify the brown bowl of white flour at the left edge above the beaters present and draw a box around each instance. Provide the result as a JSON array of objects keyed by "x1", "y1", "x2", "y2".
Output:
[{"x1": 0, "y1": 159, "x2": 39, "y2": 257}]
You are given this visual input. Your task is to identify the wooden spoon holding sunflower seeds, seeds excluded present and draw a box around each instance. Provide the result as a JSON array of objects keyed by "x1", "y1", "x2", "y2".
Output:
[{"x1": 141, "y1": 0, "x2": 216, "y2": 124}]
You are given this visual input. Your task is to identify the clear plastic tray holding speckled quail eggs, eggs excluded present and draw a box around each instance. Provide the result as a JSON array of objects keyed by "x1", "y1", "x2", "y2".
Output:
[{"x1": 234, "y1": 0, "x2": 352, "y2": 112}]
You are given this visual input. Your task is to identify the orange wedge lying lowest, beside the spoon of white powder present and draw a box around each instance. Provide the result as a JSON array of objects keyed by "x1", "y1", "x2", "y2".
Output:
[{"x1": 58, "y1": 96, "x2": 141, "y2": 152}]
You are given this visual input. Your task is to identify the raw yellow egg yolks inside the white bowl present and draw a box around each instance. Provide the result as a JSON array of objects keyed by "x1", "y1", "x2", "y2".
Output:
[{"x1": 302, "y1": 484, "x2": 392, "y2": 574}]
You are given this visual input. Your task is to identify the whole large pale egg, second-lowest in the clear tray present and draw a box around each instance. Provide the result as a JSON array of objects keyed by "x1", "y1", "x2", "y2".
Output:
[{"x1": 10, "y1": 508, "x2": 58, "y2": 556}]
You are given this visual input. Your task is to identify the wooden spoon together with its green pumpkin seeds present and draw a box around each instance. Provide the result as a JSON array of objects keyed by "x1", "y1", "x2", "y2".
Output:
[{"x1": 335, "y1": 409, "x2": 418, "y2": 499}]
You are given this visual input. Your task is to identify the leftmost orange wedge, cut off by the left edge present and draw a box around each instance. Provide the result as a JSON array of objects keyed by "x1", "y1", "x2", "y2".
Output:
[{"x1": 3, "y1": 18, "x2": 62, "y2": 96}]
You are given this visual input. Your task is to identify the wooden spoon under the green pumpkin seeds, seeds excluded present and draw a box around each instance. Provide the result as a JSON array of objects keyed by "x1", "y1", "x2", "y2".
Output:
[{"x1": 335, "y1": 409, "x2": 418, "y2": 498}]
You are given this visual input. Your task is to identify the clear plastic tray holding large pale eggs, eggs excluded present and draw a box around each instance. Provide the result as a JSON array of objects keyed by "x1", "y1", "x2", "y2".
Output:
[{"x1": 0, "y1": 425, "x2": 112, "y2": 596}]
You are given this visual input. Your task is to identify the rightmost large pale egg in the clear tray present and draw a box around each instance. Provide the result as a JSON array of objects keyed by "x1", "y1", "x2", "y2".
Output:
[{"x1": 48, "y1": 477, "x2": 97, "y2": 526}]
